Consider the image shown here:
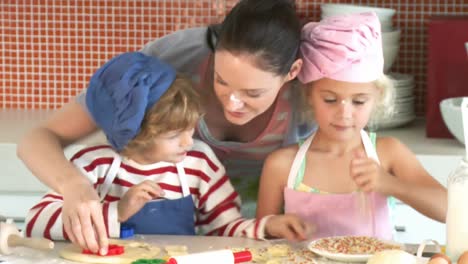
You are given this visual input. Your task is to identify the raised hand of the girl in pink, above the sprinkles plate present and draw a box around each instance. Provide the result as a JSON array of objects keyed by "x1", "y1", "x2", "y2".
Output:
[{"x1": 350, "y1": 150, "x2": 392, "y2": 194}]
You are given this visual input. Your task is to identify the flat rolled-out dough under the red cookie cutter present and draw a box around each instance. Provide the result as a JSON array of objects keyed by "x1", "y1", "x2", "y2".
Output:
[{"x1": 60, "y1": 239, "x2": 161, "y2": 264}]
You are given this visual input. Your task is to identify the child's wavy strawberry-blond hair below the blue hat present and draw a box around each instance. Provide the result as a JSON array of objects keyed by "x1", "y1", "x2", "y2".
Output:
[{"x1": 122, "y1": 75, "x2": 203, "y2": 156}]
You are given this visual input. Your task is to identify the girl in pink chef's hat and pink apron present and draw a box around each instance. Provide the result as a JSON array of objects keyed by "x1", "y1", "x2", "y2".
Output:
[{"x1": 257, "y1": 13, "x2": 447, "y2": 239}]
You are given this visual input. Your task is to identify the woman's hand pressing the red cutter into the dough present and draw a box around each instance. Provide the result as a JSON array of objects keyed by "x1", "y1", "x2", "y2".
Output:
[{"x1": 62, "y1": 178, "x2": 109, "y2": 255}]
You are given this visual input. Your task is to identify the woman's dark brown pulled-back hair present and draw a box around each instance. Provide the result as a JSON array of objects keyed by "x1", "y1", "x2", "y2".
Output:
[{"x1": 207, "y1": 0, "x2": 301, "y2": 75}]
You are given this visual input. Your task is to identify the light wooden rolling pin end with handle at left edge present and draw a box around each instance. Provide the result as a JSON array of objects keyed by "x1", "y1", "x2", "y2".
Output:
[{"x1": 0, "y1": 222, "x2": 54, "y2": 255}]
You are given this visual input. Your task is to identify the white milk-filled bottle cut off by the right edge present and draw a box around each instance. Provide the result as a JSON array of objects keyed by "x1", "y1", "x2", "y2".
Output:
[{"x1": 446, "y1": 159, "x2": 468, "y2": 263}]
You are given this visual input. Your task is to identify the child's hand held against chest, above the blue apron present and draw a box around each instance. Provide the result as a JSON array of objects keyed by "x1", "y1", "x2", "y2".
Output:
[{"x1": 117, "y1": 180, "x2": 164, "y2": 223}]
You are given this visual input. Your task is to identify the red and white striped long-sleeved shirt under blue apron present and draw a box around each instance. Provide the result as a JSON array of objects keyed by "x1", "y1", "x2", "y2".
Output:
[{"x1": 25, "y1": 140, "x2": 268, "y2": 240}]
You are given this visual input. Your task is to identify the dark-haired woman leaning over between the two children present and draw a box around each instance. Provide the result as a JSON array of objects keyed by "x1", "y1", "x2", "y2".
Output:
[{"x1": 18, "y1": 0, "x2": 311, "y2": 255}]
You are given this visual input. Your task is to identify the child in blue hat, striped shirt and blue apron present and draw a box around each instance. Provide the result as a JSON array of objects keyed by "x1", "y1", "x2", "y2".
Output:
[{"x1": 26, "y1": 52, "x2": 310, "y2": 254}]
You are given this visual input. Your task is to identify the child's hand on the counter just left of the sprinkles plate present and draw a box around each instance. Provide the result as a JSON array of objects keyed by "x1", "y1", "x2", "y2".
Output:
[{"x1": 265, "y1": 214, "x2": 315, "y2": 241}]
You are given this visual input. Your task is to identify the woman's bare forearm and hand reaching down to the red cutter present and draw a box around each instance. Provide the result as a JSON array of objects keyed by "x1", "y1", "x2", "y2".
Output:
[{"x1": 17, "y1": 100, "x2": 108, "y2": 254}]
